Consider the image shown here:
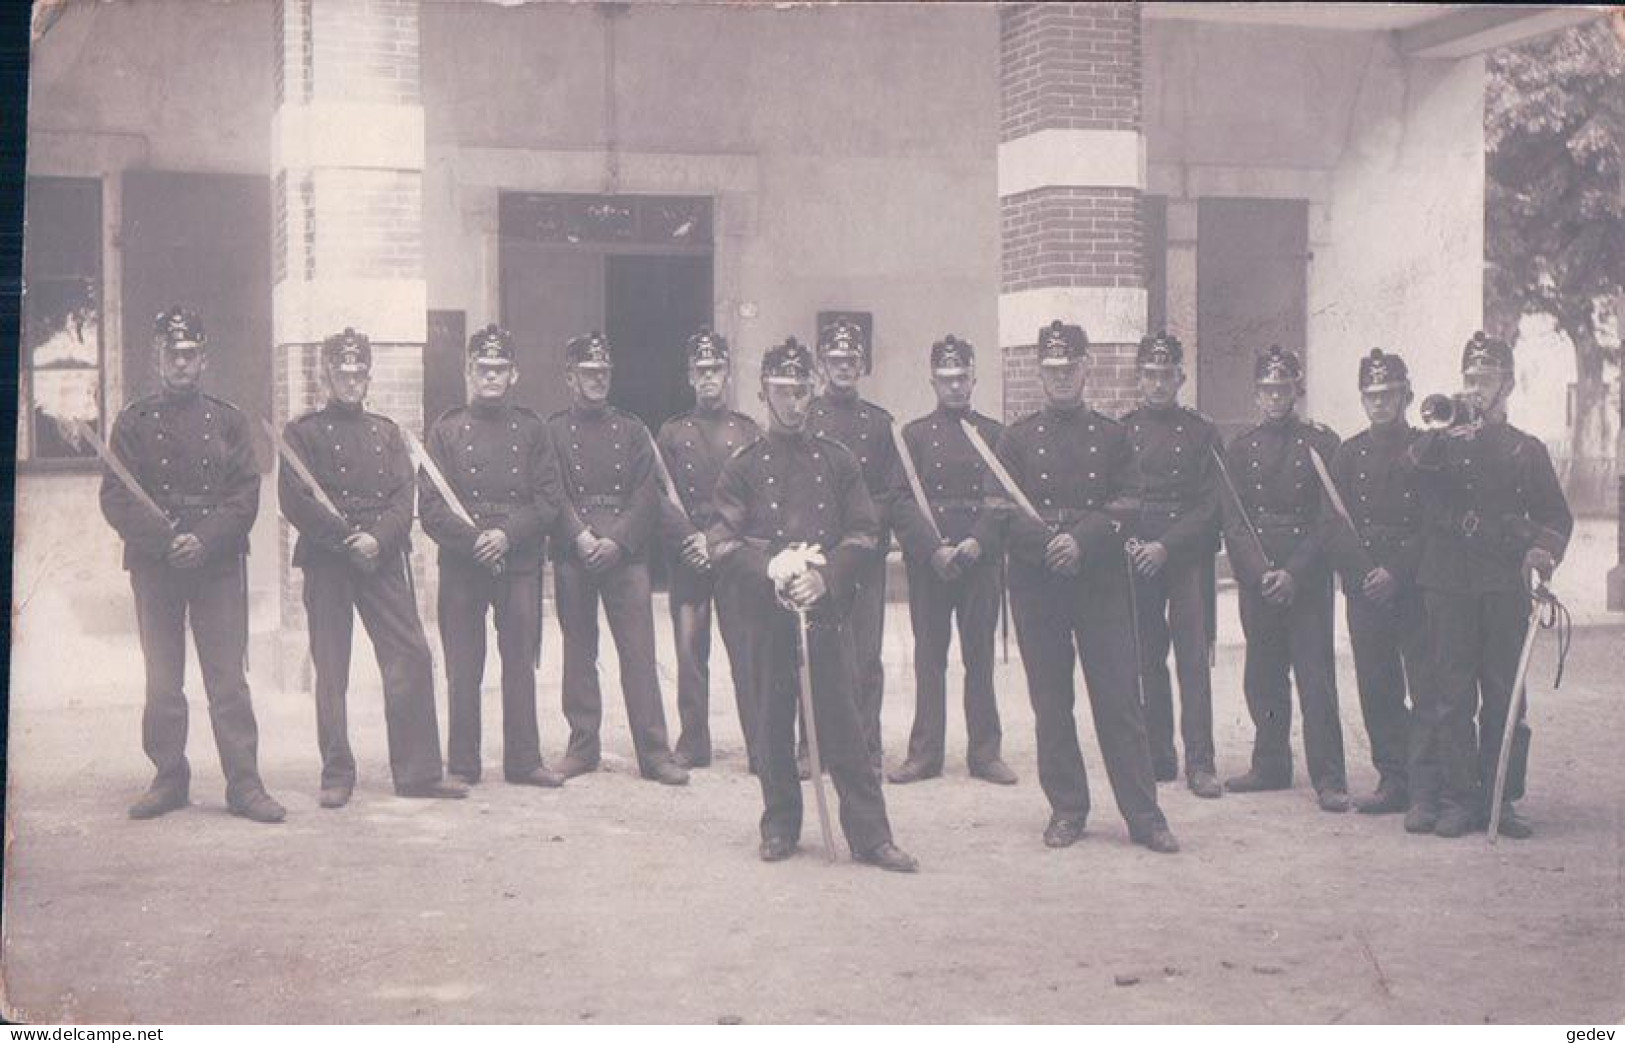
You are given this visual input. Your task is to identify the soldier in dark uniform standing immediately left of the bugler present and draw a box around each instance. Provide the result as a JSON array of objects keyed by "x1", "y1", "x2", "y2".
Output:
[{"x1": 1328, "y1": 348, "x2": 1438, "y2": 818}]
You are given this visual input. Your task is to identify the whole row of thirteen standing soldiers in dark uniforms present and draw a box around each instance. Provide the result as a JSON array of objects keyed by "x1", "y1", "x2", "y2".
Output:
[{"x1": 102, "y1": 309, "x2": 1571, "y2": 871}]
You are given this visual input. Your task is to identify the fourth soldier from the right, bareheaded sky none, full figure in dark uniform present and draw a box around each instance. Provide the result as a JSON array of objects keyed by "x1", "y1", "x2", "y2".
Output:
[{"x1": 1123, "y1": 333, "x2": 1224, "y2": 798}]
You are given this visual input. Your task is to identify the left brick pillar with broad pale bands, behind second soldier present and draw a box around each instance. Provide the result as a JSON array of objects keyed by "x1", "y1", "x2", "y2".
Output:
[{"x1": 271, "y1": 0, "x2": 427, "y2": 681}]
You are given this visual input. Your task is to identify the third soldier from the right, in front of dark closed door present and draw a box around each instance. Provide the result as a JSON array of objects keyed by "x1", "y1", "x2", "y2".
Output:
[{"x1": 1224, "y1": 344, "x2": 1349, "y2": 811}]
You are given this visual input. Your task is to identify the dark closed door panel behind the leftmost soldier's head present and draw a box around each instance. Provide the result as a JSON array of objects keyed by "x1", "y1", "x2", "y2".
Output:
[{"x1": 122, "y1": 171, "x2": 275, "y2": 454}]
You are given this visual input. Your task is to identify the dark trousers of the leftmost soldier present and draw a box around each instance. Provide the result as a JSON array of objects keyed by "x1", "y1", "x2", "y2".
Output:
[{"x1": 130, "y1": 557, "x2": 263, "y2": 804}]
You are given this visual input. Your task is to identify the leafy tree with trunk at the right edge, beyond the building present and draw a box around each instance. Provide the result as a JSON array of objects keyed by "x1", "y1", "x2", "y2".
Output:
[{"x1": 1484, "y1": 11, "x2": 1625, "y2": 457}]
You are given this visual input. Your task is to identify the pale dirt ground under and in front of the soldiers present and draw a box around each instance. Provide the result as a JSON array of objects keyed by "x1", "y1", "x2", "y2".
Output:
[{"x1": 3, "y1": 578, "x2": 1625, "y2": 1024}]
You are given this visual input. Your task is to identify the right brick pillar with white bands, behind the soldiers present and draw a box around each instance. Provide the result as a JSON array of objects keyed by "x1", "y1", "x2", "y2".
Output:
[{"x1": 999, "y1": 3, "x2": 1146, "y2": 419}]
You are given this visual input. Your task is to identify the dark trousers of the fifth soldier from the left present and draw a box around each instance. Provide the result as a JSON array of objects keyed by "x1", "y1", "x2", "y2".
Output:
[{"x1": 668, "y1": 564, "x2": 757, "y2": 767}]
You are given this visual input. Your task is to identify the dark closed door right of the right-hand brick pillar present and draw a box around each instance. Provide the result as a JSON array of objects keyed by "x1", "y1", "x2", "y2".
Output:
[{"x1": 1196, "y1": 200, "x2": 1311, "y2": 439}]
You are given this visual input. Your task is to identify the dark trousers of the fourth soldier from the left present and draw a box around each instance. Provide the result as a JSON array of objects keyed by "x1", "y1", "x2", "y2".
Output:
[{"x1": 553, "y1": 560, "x2": 671, "y2": 775}]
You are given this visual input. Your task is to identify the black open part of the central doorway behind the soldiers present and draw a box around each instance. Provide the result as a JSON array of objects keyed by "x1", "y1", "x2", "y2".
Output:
[{"x1": 605, "y1": 255, "x2": 712, "y2": 431}]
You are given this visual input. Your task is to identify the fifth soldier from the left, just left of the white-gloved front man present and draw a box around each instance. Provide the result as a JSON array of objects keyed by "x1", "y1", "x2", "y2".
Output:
[{"x1": 658, "y1": 328, "x2": 762, "y2": 772}]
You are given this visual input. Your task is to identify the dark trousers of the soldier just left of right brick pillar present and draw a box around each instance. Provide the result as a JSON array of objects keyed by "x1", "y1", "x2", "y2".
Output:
[{"x1": 907, "y1": 554, "x2": 1003, "y2": 772}]
